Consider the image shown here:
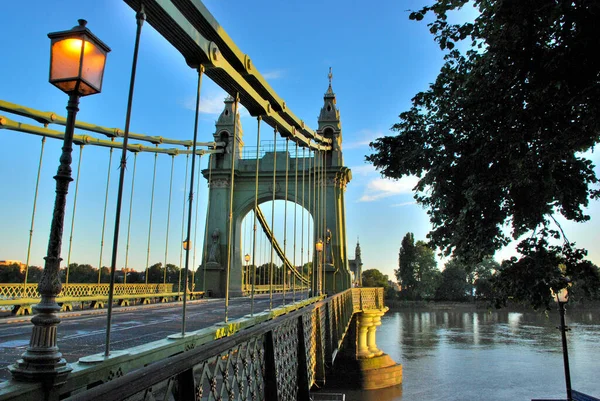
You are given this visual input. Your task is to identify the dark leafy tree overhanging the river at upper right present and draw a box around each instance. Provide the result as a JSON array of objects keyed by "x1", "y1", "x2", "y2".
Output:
[{"x1": 367, "y1": 0, "x2": 600, "y2": 303}]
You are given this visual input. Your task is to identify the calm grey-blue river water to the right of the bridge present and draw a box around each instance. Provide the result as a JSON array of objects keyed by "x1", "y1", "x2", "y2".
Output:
[{"x1": 334, "y1": 306, "x2": 600, "y2": 401}]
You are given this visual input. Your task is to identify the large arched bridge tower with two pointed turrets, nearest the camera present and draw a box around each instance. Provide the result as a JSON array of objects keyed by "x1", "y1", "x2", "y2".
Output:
[{"x1": 200, "y1": 76, "x2": 352, "y2": 297}]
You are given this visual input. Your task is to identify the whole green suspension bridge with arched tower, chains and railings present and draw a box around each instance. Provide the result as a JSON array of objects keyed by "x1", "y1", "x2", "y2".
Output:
[{"x1": 0, "y1": 0, "x2": 402, "y2": 400}]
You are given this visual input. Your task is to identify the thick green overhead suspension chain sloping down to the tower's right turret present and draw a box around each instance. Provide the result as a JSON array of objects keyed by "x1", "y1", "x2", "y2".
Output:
[{"x1": 124, "y1": 0, "x2": 331, "y2": 150}]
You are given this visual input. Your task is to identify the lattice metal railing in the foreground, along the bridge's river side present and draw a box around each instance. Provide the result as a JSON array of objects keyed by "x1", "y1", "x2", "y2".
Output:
[{"x1": 0, "y1": 288, "x2": 383, "y2": 401}]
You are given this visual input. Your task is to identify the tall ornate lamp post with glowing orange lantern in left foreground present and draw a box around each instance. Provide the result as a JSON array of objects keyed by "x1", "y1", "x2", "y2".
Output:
[{"x1": 9, "y1": 20, "x2": 110, "y2": 386}]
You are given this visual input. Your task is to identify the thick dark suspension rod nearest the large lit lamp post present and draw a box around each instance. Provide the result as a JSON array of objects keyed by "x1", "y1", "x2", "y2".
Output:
[{"x1": 104, "y1": 3, "x2": 146, "y2": 356}]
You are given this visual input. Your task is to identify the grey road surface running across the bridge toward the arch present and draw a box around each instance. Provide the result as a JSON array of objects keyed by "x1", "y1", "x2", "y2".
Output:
[{"x1": 0, "y1": 293, "x2": 306, "y2": 381}]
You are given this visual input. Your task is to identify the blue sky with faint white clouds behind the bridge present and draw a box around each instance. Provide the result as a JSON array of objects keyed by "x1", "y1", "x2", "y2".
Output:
[{"x1": 0, "y1": 0, "x2": 600, "y2": 277}]
